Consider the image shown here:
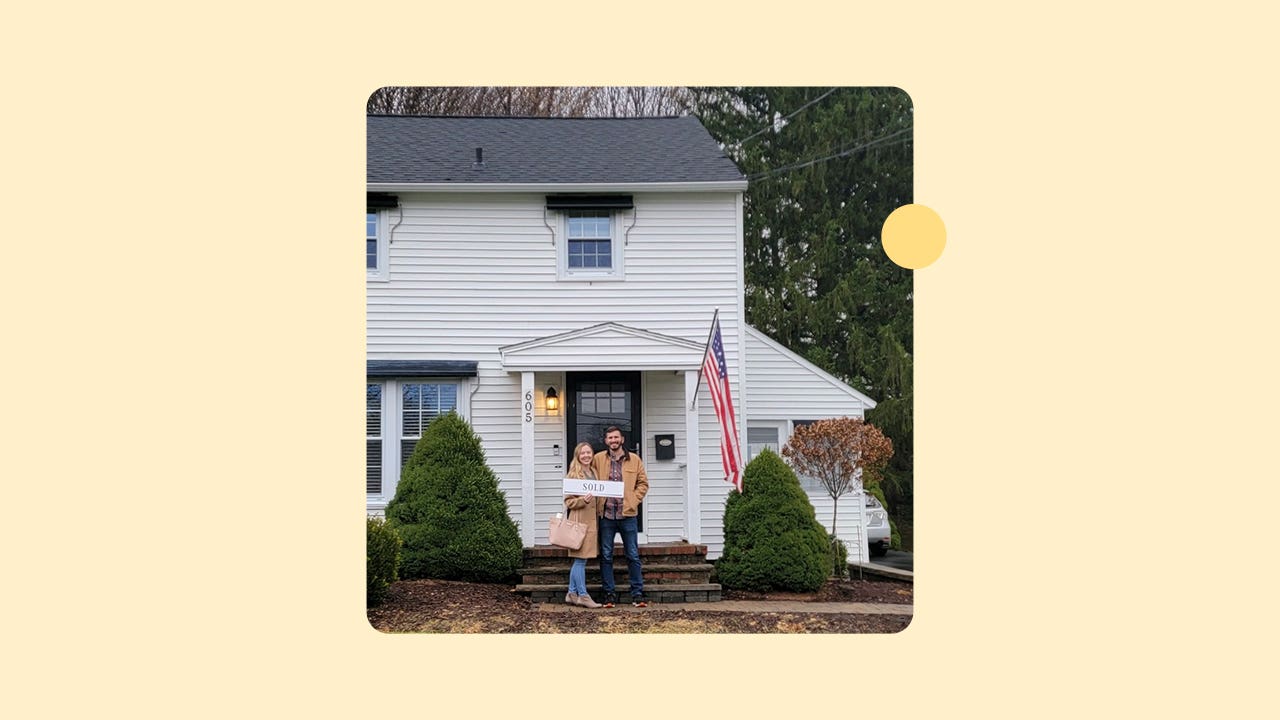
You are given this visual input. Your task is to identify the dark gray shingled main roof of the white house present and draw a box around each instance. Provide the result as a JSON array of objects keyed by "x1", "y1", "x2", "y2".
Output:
[{"x1": 366, "y1": 115, "x2": 744, "y2": 184}]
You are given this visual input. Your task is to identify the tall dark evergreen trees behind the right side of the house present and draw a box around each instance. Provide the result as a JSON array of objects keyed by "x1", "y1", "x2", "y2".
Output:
[{"x1": 691, "y1": 87, "x2": 914, "y2": 527}]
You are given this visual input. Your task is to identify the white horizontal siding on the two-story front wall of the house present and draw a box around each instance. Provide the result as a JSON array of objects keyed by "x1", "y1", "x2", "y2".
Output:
[{"x1": 366, "y1": 192, "x2": 742, "y2": 527}]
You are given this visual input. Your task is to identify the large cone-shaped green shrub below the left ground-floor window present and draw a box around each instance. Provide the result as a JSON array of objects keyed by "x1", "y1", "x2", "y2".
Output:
[{"x1": 387, "y1": 413, "x2": 521, "y2": 583}]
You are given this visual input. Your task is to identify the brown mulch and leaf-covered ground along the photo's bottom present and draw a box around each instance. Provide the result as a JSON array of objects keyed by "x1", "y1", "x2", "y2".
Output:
[{"x1": 369, "y1": 580, "x2": 911, "y2": 634}]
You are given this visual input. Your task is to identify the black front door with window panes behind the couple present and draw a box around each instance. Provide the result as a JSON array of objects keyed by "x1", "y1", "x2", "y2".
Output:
[{"x1": 566, "y1": 373, "x2": 644, "y2": 532}]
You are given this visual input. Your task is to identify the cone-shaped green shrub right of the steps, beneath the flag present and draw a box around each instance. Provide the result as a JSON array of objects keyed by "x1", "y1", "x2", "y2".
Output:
[{"x1": 716, "y1": 450, "x2": 831, "y2": 592}]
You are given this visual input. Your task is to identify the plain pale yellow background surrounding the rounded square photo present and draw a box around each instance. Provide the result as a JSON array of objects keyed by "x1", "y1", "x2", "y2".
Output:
[{"x1": 0, "y1": 3, "x2": 1280, "y2": 717}]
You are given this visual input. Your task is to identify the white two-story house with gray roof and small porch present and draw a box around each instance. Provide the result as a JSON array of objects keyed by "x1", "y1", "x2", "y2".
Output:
[{"x1": 366, "y1": 115, "x2": 874, "y2": 560}]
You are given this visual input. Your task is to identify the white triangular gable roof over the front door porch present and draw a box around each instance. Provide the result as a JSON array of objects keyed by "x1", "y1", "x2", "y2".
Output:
[{"x1": 498, "y1": 323, "x2": 707, "y2": 372}]
